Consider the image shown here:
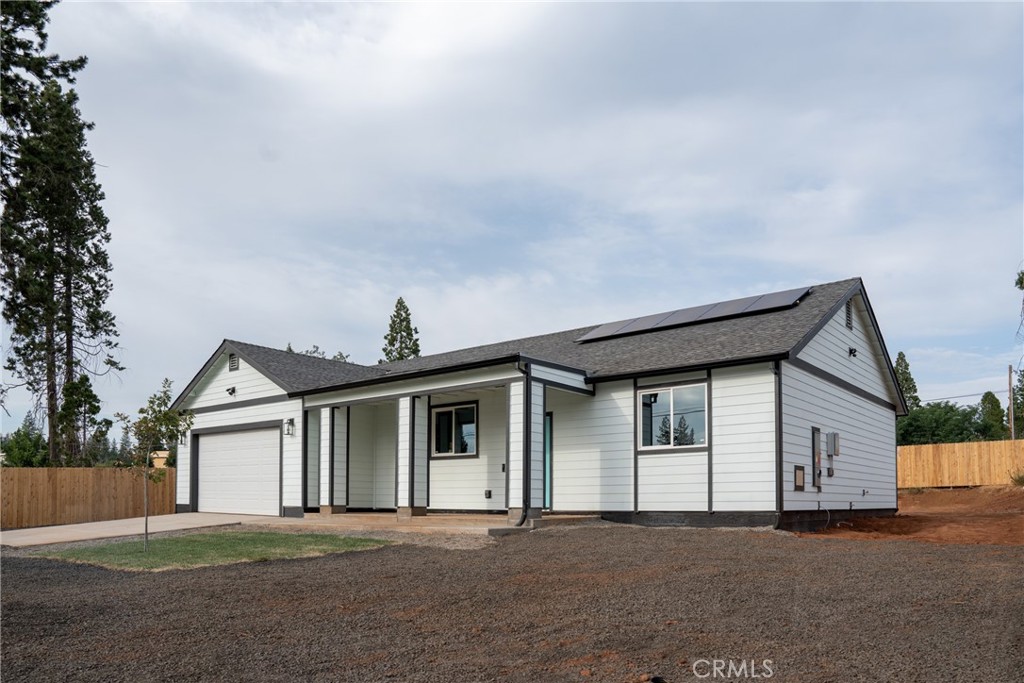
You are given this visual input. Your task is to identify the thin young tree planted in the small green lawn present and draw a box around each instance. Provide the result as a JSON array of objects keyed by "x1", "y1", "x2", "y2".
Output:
[{"x1": 117, "y1": 379, "x2": 194, "y2": 550}]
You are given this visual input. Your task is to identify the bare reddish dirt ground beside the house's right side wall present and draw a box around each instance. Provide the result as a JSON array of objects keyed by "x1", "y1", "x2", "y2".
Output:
[{"x1": 801, "y1": 486, "x2": 1024, "y2": 546}]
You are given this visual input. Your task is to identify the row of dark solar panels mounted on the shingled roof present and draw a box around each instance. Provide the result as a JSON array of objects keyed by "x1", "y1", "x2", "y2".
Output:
[{"x1": 577, "y1": 287, "x2": 811, "y2": 342}]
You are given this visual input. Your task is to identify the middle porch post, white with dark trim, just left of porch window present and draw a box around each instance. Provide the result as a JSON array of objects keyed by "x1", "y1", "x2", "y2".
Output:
[{"x1": 396, "y1": 396, "x2": 429, "y2": 519}]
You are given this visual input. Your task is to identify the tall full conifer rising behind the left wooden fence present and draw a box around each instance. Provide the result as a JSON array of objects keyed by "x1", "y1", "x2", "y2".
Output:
[{"x1": 0, "y1": 81, "x2": 122, "y2": 465}]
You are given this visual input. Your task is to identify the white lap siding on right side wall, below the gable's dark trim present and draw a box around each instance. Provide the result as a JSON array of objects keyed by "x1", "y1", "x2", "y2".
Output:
[{"x1": 782, "y1": 362, "x2": 896, "y2": 510}]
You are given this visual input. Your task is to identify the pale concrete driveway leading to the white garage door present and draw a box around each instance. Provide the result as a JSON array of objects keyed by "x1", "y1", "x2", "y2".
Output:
[{"x1": 0, "y1": 512, "x2": 276, "y2": 548}]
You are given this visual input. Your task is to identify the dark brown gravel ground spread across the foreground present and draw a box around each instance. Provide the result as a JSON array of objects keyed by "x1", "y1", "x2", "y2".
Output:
[{"x1": 0, "y1": 525, "x2": 1024, "y2": 683}]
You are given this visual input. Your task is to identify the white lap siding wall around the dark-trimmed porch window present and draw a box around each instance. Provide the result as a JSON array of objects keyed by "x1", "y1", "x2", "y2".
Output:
[{"x1": 430, "y1": 387, "x2": 505, "y2": 510}]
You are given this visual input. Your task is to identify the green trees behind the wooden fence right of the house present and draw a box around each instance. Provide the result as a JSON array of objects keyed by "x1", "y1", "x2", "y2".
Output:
[{"x1": 895, "y1": 351, "x2": 1024, "y2": 445}]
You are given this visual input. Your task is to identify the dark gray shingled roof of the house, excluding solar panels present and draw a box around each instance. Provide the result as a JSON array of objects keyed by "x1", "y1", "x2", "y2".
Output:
[{"x1": 178, "y1": 279, "x2": 863, "y2": 400}]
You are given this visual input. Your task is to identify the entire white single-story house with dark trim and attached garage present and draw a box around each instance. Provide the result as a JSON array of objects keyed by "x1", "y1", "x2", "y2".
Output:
[{"x1": 175, "y1": 279, "x2": 906, "y2": 526}]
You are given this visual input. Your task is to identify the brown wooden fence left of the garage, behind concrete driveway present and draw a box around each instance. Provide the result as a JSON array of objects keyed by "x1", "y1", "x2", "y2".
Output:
[{"x1": 0, "y1": 467, "x2": 175, "y2": 529}]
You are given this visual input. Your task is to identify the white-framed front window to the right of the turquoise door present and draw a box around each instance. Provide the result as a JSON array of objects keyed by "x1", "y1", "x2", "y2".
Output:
[{"x1": 639, "y1": 384, "x2": 708, "y2": 449}]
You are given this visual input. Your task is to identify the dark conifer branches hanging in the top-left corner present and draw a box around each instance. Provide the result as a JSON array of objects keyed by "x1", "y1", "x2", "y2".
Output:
[{"x1": 0, "y1": 0, "x2": 86, "y2": 192}]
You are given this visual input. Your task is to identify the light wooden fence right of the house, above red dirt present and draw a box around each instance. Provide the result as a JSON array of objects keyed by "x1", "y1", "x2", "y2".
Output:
[{"x1": 896, "y1": 439, "x2": 1024, "y2": 488}]
